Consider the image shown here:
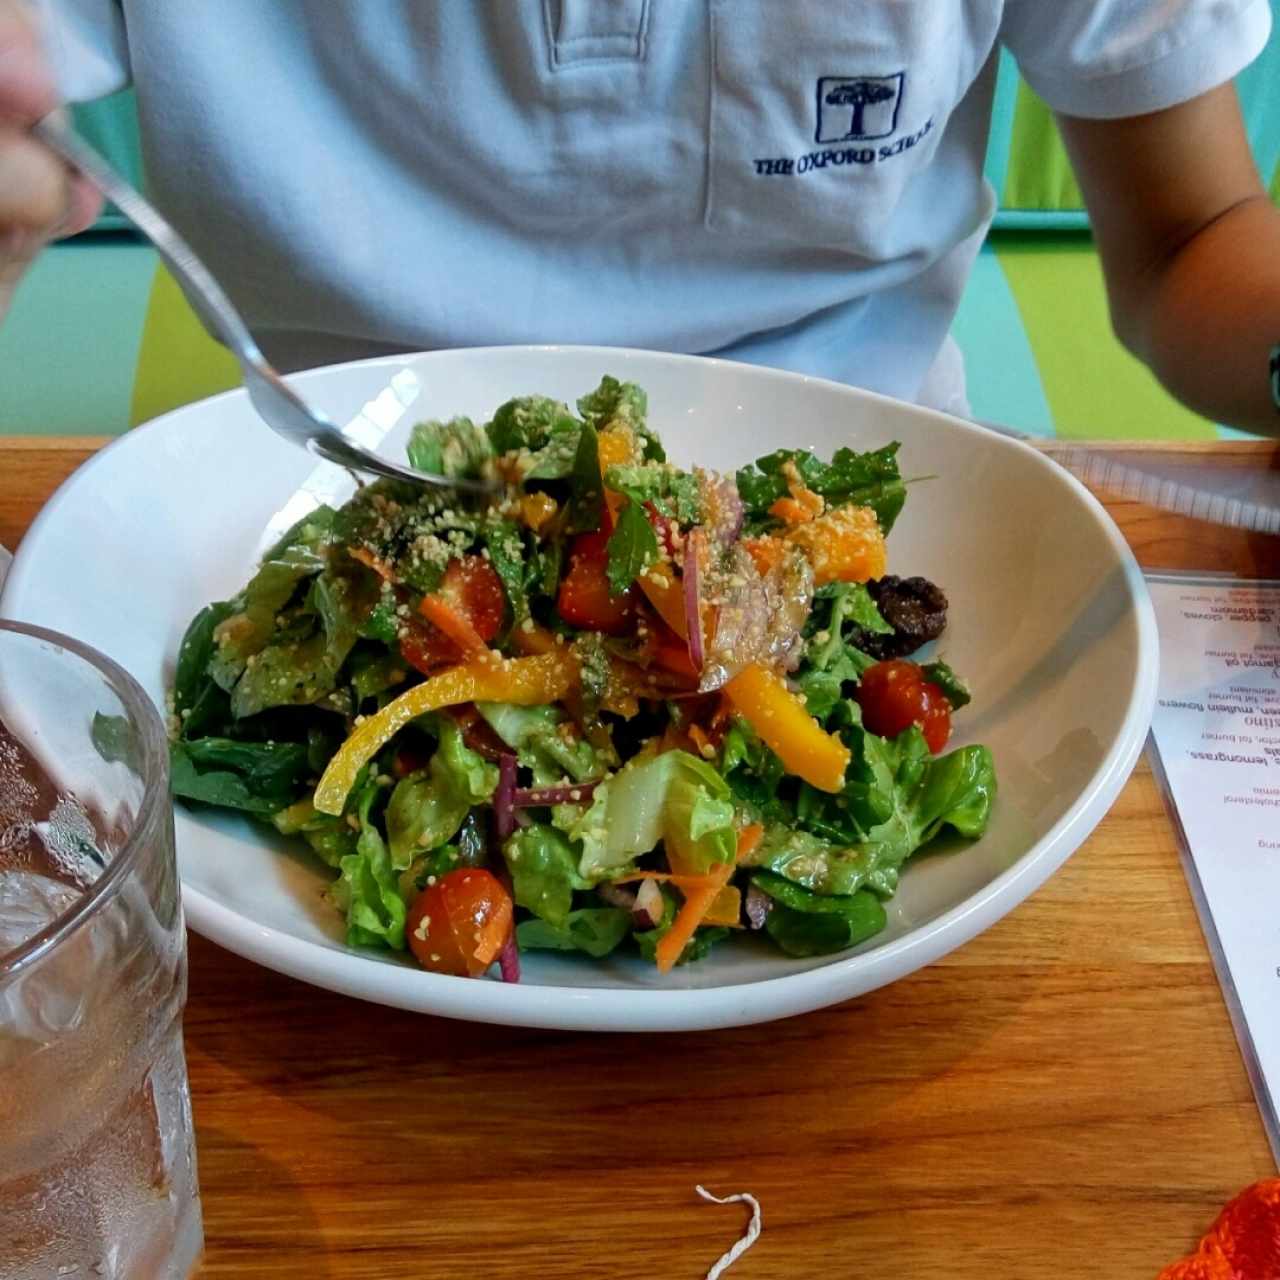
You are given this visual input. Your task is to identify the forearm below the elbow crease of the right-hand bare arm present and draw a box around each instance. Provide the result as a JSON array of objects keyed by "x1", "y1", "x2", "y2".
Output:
[{"x1": 1115, "y1": 196, "x2": 1280, "y2": 435}]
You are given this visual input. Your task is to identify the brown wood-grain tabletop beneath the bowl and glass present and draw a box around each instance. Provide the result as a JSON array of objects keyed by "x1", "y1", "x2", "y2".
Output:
[{"x1": 0, "y1": 439, "x2": 1280, "y2": 1280}]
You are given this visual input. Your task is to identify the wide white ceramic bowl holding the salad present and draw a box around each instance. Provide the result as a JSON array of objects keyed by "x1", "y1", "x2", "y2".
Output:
[{"x1": 0, "y1": 347, "x2": 1157, "y2": 1030}]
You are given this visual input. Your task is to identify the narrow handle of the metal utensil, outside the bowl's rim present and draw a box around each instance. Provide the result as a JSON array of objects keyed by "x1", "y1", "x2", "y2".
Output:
[{"x1": 31, "y1": 111, "x2": 265, "y2": 364}]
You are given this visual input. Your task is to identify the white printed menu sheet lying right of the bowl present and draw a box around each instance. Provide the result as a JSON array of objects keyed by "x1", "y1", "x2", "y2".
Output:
[{"x1": 1147, "y1": 573, "x2": 1280, "y2": 1164}]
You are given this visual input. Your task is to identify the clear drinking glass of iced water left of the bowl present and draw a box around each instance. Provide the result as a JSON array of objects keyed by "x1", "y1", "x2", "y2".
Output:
[{"x1": 0, "y1": 621, "x2": 202, "y2": 1280}]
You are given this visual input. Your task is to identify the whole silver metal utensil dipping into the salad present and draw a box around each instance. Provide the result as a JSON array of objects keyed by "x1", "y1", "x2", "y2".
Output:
[{"x1": 32, "y1": 113, "x2": 494, "y2": 493}]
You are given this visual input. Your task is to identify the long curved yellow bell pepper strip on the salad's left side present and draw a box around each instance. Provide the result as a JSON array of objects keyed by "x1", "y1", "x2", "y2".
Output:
[{"x1": 315, "y1": 649, "x2": 579, "y2": 814}]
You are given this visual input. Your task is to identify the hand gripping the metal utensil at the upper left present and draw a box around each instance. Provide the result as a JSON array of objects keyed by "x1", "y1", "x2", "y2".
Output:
[{"x1": 0, "y1": 0, "x2": 102, "y2": 316}]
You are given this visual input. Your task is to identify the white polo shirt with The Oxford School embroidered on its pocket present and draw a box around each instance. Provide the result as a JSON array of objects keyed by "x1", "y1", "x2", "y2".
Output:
[{"x1": 38, "y1": 0, "x2": 1270, "y2": 407}]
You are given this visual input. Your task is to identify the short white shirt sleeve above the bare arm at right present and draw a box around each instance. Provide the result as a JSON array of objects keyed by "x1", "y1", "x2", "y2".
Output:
[{"x1": 1001, "y1": 0, "x2": 1271, "y2": 119}]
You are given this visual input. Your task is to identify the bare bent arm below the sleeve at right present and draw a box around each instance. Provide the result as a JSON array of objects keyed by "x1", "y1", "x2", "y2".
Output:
[{"x1": 1059, "y1": 84, "x2": 1280, "y2": 435}]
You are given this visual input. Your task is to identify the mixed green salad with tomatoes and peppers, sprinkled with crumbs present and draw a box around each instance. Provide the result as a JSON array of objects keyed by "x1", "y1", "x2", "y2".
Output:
[{"x1": 170, "y1": 378, "x2": 996, "y2": 980}]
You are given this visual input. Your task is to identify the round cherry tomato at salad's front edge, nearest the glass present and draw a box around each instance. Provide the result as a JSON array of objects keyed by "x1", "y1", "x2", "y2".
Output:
[{"x1": 404, "y1": 867, "x2": 515, "y2": 978}]
